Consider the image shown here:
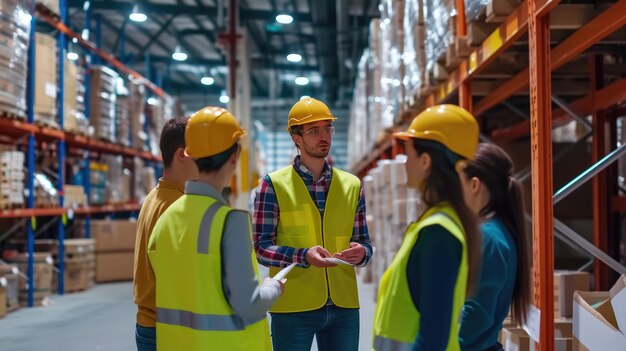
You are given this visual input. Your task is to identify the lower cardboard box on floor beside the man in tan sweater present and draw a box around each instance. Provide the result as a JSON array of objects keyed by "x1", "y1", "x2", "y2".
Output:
[{"x1": 96, "y1": 251, "x2": 135, "y2": 283}]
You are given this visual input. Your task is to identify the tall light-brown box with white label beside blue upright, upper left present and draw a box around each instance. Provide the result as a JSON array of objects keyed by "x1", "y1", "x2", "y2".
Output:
[{"x1": 35, "y1": 33, "x2": 57, "y2": 119}]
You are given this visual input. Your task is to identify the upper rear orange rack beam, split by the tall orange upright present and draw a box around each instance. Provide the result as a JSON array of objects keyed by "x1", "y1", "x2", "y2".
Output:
[{"x1": 474, "y1": 0, "x2": 626, "y2": 114}]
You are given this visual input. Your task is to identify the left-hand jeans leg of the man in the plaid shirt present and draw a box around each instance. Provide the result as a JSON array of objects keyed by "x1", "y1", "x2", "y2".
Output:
[{"x1": 271, "y1": 307, "x2": 326, "y2": 351}]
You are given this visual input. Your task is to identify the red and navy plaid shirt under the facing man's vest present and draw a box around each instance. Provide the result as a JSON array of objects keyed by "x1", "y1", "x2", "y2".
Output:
[{"x1": 252, "y1": 156, "x2": 372, "y2": 267}]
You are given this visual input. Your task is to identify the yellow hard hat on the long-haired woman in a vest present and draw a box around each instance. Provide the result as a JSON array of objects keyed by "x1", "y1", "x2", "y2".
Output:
[{"x1": 393, "y1": 105, "x2": 478, "y2": 160}]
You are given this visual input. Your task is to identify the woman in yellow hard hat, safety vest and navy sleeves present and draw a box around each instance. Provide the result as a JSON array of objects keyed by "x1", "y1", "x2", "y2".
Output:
[{"x1": 373, "y1": 105, "x2": 481, "y2": 351}]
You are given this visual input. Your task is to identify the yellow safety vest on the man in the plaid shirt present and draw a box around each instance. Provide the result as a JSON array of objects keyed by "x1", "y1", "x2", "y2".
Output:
[{"x1": 269, "y1": 166, "x2": 361, "y2": 313}]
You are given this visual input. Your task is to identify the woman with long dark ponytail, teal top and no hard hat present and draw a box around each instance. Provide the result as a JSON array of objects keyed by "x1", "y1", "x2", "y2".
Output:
[{"x1": 459, "y1": 144, "x2": 531, "y2": 351}]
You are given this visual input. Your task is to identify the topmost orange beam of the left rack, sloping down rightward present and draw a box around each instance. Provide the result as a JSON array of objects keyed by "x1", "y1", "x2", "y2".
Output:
[{"x1": 36, "y1": 6, "x2": 165, "y2": 96}]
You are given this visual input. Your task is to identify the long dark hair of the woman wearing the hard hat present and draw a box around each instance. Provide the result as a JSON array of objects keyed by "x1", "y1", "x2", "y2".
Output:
[{"x1": 413, "y1": 139, "x2": 482, "y2": 296}]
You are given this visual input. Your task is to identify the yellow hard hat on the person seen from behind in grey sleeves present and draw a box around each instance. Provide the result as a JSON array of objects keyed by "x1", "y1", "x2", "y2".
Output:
[{"x1": 185, "y1": 106, "x2": 246, "y2": 159}]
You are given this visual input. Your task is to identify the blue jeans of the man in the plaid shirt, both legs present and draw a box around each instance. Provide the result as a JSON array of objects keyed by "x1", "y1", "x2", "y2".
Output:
[{"x1": 271, "y1": 305, "x2": 359, "y2": 351}]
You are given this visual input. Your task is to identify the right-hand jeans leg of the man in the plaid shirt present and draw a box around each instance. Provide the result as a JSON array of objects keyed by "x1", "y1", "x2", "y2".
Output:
[{"x1": 316, "y1": 306, "x2": 359, "y2": 351}]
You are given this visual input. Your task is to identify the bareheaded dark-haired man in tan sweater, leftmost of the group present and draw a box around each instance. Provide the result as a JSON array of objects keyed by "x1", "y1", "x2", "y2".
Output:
[{"x1": 133, "y1": 117, "x2": 198, "y2": 351}]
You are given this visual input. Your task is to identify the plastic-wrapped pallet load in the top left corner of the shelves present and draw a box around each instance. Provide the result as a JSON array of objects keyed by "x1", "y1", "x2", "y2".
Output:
[{"x1": 0, "y1": 0, "x2": 30, "y2": 119}]
